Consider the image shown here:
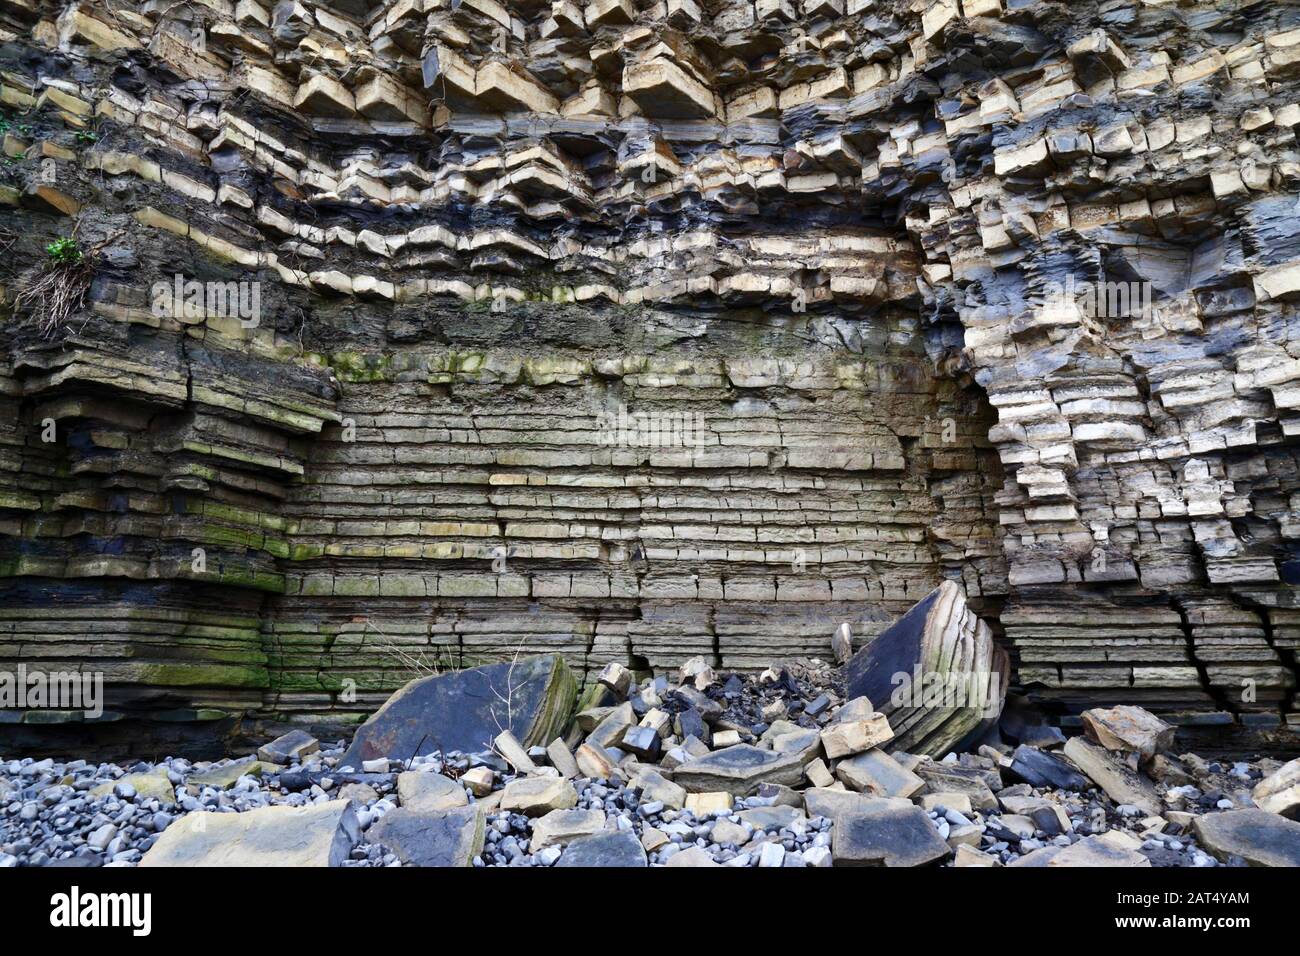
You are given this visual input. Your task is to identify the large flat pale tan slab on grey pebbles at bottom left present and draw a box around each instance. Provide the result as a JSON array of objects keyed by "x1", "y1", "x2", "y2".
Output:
[{"x1": 140, "y1": 800, "x2": 361, "y2": 866}]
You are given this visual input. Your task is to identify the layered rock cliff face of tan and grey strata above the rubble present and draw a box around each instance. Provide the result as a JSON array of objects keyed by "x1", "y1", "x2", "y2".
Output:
[{"x1": 0, "y1": 0, "x2": 1300, "y2": 740}]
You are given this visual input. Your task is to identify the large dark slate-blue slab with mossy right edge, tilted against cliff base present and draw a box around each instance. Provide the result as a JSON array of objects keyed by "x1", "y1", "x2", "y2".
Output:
[{"x1": 341, "y1": 654, "x2": 577, "y2": 769}]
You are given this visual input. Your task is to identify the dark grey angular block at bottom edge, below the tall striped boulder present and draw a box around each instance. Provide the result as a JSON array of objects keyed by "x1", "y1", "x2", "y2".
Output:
[{"x1": 831, "y1": 800, "x2": 952, "y2": 866}]
